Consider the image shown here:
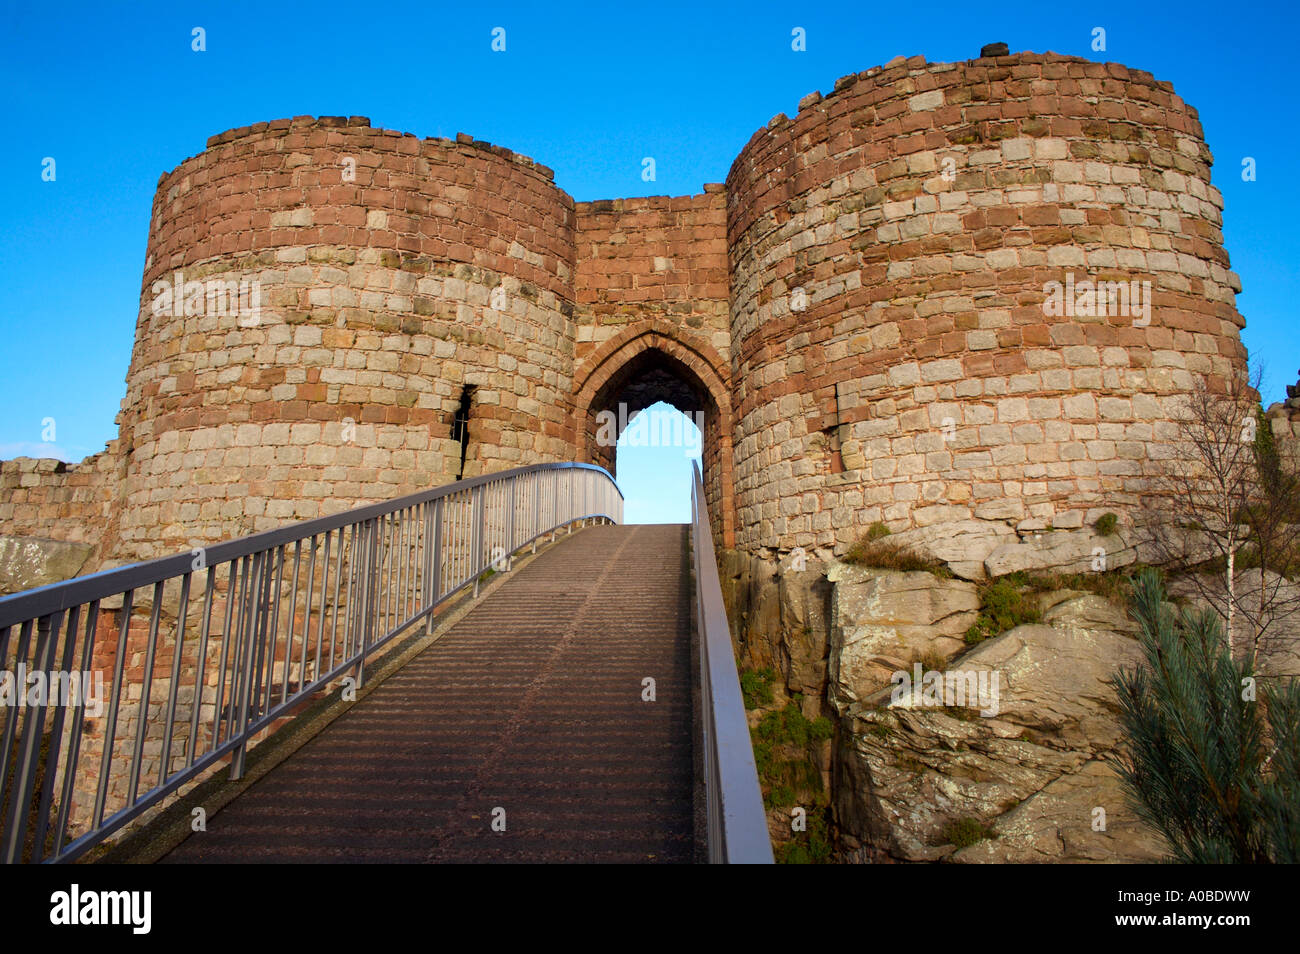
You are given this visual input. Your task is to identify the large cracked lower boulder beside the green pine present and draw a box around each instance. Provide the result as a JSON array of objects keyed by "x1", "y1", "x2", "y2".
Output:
[{"x1": 832, "y1": 593, "x2": 1161, "y2": 862}]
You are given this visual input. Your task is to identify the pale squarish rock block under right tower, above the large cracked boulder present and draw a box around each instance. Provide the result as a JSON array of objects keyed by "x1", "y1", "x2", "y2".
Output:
[{"x1": 828, "y1": 564, "x2": 979, "y2": 712}]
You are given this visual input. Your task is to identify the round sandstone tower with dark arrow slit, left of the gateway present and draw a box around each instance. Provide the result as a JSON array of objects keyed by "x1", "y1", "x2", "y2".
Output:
[{"x1": 120, "y1": 117, "x2": 573, "y2": 559}]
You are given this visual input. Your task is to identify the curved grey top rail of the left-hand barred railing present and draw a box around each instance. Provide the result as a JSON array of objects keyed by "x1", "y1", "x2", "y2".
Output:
[{"x1": 0, "y1": 461, "x2": 623, "y2": 629}]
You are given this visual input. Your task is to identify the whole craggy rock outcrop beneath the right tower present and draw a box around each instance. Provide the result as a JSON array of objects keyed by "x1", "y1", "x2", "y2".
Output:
[{"x1": 723, "y1": 545, "x2": 1300, "y2": 863}]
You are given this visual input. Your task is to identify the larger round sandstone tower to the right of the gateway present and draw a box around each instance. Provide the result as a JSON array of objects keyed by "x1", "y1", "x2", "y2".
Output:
[{"x1": 727, "y1": 53, "x2": 1245, "y2": 561}]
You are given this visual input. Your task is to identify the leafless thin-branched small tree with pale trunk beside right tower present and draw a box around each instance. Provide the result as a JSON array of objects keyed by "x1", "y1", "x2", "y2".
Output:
[{"x1": 1148, "y1": 377, "x2": 1300, "y2": 664}]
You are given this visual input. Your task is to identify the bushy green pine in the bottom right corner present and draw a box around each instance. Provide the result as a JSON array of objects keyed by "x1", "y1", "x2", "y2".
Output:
[{"x1": 1113, "y1": 569, "x2": 1300, "y2": 863}]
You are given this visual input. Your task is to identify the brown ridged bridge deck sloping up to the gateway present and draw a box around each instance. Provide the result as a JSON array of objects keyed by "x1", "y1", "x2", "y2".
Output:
[{"x1": 164, "y1": 525, "x2": 694, "y2": 863}]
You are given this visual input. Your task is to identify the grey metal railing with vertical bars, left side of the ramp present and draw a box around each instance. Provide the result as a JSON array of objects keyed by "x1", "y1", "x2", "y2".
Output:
[{"x1": 0, "y1": 463, "x2": 623, "y2": 863}]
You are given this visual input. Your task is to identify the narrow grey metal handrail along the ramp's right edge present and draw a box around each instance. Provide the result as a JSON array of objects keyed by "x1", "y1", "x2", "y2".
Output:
[{"x1": 690, "y1": 463, "x2": 774, "y2": 864}]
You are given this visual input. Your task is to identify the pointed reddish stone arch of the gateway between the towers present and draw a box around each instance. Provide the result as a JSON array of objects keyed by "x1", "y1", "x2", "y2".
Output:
[{"x1": 573, "y1": 321, "x2": 736, "y2": 547}]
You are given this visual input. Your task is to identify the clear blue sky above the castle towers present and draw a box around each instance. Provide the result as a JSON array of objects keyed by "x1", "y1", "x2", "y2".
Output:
[{"x1": 0, "y1": 0, "x2": 1300, "y2": 522}]
